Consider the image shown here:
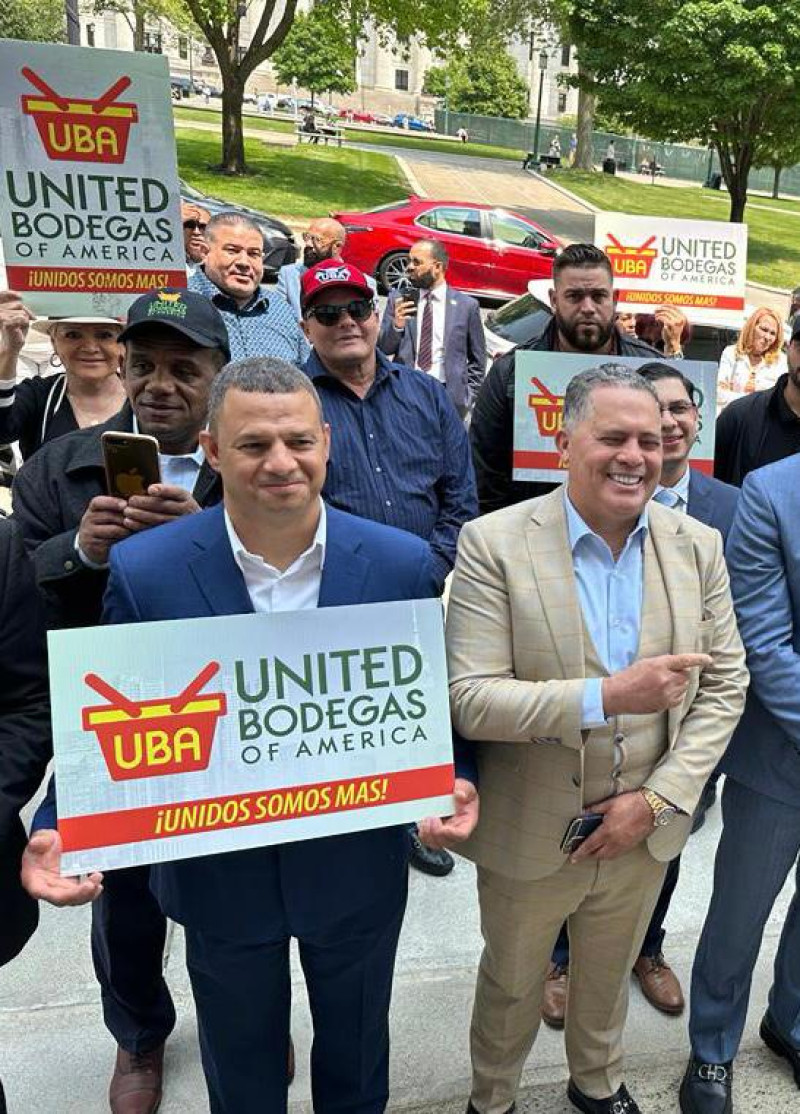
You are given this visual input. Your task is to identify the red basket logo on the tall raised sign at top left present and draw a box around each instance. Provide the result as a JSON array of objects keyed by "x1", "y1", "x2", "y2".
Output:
[{"x1": 21, "y1": 66, "x2": 139, "y2": 163}]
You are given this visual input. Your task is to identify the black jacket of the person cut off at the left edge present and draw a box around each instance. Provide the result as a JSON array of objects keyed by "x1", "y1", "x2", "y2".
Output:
[{"x1": 0, "y1": 519, "x2": 52, "y2": 965}]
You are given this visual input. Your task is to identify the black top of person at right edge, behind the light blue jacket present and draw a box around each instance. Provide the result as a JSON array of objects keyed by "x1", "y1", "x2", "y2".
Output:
[{"x1": 714, "y1": 372, "x2": 800, "y2": 487}]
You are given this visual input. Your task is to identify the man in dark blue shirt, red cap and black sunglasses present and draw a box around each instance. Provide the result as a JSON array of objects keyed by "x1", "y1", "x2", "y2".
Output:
[{"x1": 300, "y1": 260, "x2": 478, "y2": 876}]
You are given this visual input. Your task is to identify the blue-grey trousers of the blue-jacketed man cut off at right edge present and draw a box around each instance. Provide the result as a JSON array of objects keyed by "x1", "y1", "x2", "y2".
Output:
[{"x1": 689, "y1": 775, "x2": 800, "y2": 1064}]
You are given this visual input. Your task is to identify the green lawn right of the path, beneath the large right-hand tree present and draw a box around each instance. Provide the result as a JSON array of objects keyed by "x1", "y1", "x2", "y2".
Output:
[{"x1": 556, "y1": 170, "x2": 800, "y2": 289}]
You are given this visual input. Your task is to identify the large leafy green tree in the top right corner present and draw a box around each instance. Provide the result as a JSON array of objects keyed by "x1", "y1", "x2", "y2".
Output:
[{"x1": 575, "y1": 0, "x2": 800, "y2": 221}]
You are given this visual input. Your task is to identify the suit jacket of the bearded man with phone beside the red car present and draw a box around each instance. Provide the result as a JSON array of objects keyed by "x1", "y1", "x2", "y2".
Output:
[{"x1": 378, "y1": 286, "x2": 486, "y2": 416}]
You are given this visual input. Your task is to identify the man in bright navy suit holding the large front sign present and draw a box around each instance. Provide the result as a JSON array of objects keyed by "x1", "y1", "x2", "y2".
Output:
[{"x1": 28, "y1": 359, "x2": 478, "y2": 1114}]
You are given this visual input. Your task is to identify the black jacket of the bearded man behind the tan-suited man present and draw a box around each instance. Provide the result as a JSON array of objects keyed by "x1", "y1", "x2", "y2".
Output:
[{"x1": 469, "y1": 316, "x2": 664, "y2": 515}]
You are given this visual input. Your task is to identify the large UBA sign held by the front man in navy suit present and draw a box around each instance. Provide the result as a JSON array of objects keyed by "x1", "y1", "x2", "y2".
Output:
[{"x1": 49, "y1": 599, "x2": 453, "y2": 873}]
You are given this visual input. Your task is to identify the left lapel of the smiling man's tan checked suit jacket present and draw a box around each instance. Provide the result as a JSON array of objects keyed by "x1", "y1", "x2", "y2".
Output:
[{"x1": 525, "y1": 488, "x2": 586, "y2": 678}]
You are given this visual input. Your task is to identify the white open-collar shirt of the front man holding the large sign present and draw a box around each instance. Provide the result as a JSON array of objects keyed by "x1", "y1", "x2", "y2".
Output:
[{"x1": 225, "y1": 499, "x2": 328, "y2": 614}]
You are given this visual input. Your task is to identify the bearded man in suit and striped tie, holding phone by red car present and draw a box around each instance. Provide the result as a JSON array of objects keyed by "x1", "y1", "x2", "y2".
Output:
[{"x1": 378, "y1": 240, "x2": 486, "y2": 417}]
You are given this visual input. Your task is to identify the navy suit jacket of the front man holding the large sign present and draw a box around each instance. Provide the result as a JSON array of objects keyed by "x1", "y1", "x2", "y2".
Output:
[{"x1": 104, "y1": 506, "x2": 469, "y2": 941}]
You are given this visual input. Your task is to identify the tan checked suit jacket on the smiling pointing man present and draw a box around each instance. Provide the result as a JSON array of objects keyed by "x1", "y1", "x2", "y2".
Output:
[{"x1": 447, "y1": 489, "x2": 748, "y2": 880}]
